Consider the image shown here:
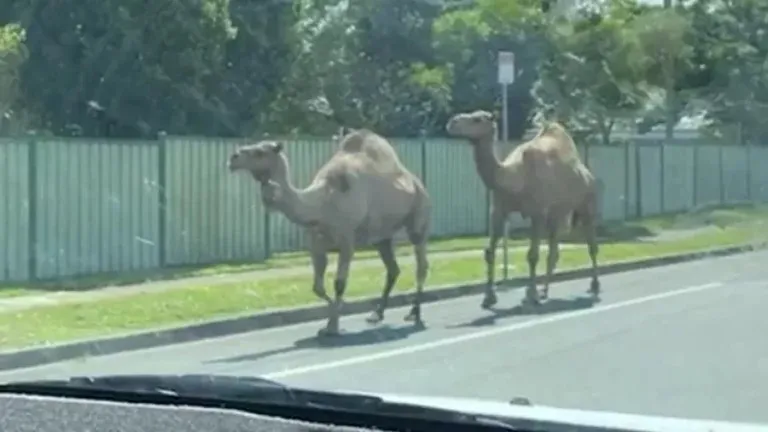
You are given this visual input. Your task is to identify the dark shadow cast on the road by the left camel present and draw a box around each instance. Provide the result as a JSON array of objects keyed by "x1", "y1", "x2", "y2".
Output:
[{"x1": 205, "y1": 324, "x2": 427, "y2": 364}]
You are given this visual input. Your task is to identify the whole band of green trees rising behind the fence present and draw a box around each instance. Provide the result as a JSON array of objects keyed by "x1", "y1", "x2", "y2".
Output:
[{"x1": 0, "y1": 0, "x2": 768, "y2": 142}]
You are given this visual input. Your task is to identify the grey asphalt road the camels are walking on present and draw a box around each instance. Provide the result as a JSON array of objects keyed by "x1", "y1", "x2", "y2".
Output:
[{"x1": 0, "y1": 252, "x2": 768, "y2": 423}]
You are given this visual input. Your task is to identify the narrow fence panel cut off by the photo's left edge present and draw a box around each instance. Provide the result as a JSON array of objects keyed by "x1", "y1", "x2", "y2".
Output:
[{"x1": 0, "y1": 139, "x2": 30, "y2": 281}]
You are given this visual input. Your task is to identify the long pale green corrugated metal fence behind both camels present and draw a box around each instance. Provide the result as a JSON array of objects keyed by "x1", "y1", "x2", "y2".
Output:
[{"x1": 0, "y1": 137, "x2": 768, "y2": 281}]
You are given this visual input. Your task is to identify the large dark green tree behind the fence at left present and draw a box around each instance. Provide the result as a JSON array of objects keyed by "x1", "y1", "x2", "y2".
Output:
[{"x1": 12, "y1": 0, "x2": 236, "y2": 136}]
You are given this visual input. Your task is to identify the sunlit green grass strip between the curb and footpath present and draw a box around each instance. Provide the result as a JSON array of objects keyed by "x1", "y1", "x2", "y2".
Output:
[{"x1": 0, "y1": 206, "x2": 766, "y2": 350}]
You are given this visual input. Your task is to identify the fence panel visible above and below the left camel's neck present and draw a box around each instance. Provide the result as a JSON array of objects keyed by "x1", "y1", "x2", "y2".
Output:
[{"x1": 269, "y1": 138, "x2": 338, "y2": 253}]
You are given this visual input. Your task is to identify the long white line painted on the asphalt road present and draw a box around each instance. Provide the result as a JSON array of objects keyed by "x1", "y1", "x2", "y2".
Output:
[{"x1": 262, "y1": 282, "x2": 723, "y2": 379}]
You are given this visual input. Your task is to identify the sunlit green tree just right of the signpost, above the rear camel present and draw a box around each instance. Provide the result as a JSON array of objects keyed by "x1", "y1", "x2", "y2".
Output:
[{"x1": 534, "y1": 0, "x2": 690, "y2": 144}]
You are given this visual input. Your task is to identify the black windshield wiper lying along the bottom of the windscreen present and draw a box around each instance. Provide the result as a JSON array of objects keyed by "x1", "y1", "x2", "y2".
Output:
[{"x1": 0, "y1": 374, "x2": 517, "y2": 430}]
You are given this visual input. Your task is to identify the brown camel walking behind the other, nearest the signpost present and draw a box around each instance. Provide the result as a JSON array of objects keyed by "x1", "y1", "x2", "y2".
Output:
[{"x1": 446, "y1": 111, "x2": 600, "y2": 308}]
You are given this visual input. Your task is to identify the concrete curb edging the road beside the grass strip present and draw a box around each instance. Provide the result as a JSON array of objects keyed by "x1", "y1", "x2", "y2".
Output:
[{"x1": 0, "y1": 242, "x2": 768, "y2": 370}]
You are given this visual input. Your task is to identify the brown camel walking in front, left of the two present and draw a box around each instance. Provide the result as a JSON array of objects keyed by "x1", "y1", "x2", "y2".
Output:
[{"x1": 229, "y1": 130, "x2": 431, "y2": 335}]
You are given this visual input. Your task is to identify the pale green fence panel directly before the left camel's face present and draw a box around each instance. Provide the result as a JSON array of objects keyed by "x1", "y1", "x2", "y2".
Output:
[{"x1": 163, "y1": 137, "x2": 266, "y2": 265}]
